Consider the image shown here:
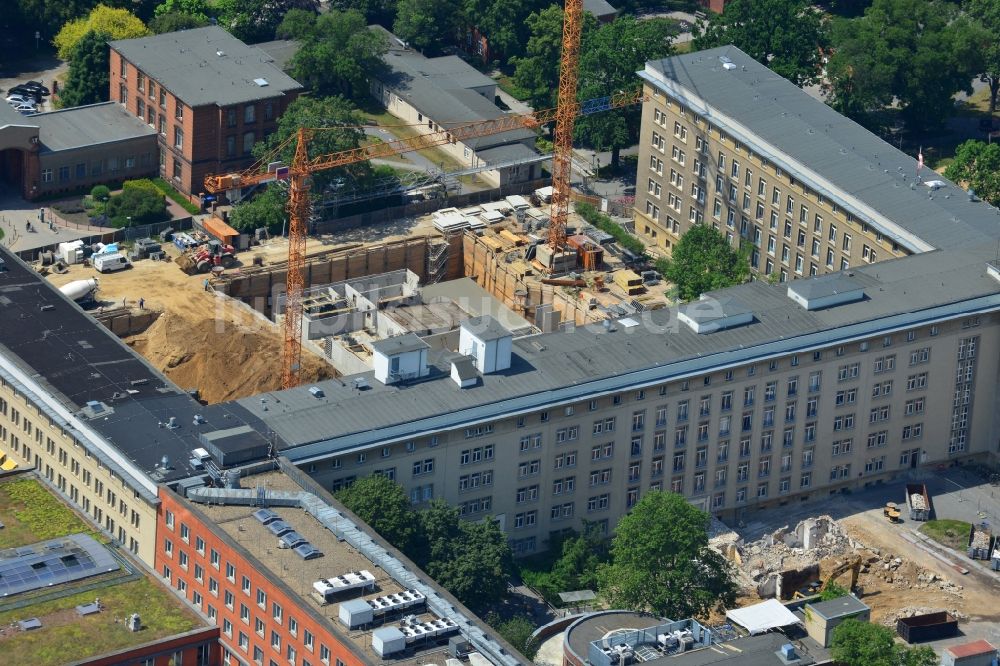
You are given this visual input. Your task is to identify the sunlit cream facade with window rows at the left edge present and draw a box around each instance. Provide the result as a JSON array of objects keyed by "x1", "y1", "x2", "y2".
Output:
[{"x1": 0, "y1": 373, "x2": 156, "y2": 566}]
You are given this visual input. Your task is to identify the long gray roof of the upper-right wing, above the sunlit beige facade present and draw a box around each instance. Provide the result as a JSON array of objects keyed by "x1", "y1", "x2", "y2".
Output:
[{"x1": 639, "y1": 46, "x2": 1000, "y2": 252}]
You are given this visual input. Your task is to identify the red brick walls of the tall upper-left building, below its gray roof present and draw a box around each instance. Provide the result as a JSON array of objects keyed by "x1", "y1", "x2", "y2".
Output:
[{"x1": 110, "y1": 50, "x2": 298, "y2": 197}]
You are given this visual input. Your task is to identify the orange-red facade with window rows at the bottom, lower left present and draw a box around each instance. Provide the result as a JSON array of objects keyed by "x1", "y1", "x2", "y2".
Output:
[{"x1": 155, "y1": 488, "x2": 364, "y2": 666}]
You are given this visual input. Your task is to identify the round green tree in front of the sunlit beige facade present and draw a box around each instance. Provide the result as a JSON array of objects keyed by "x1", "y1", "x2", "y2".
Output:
[{"x1": 663, "y1": 224, "x2": 750, "y2": 301}]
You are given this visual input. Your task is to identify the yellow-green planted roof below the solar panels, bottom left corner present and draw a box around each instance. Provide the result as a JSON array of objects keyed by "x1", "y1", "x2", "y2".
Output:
[{"x1": 0, "y1": 577, "x2": 201, "y2": 666}]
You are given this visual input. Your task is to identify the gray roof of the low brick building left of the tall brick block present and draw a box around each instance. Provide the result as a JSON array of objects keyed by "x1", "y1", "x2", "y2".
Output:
[{"x1": 31, "y1": 102, "x2": 156, "y2": 153}]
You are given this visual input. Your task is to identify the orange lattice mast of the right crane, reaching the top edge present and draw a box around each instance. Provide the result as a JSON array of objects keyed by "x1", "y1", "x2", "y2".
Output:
[{"x1": 549, "y1": 0, "x2": 583, "y2": 252}]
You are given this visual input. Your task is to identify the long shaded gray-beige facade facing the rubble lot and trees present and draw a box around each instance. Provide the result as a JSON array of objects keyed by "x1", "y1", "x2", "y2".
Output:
[{"x1": 304, "y1": 315, "x2": 1000, "y2": 554}]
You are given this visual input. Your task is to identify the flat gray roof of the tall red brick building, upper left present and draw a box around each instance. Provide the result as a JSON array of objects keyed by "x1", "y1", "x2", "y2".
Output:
[{"x1": 108, "y1": 25, "x2": 302, "y2": 106}]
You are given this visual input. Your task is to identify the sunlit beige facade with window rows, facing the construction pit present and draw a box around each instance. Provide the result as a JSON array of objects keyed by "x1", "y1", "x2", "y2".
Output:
[{"x1": 635, "y1": 84, "x2": 911, "y2": 282}]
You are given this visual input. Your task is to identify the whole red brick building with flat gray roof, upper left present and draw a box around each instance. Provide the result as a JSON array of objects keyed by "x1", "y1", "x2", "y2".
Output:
[{"x1": 109, "y1": 26, "x2": 302, "y2": 197}]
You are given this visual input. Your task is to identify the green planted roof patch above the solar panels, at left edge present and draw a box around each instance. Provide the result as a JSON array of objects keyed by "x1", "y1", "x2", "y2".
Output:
[{"x1": 0, "y1": 478, "x2": 104, "y2": 549}]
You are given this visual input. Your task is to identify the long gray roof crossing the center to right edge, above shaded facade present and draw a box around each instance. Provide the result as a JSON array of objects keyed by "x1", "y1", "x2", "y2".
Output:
[{"x1": 238, "y1": 248, "x2": 1000, "y2": 461}]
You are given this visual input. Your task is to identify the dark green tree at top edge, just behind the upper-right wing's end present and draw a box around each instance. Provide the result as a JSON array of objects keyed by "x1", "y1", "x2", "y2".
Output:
[{"x1": 694, "y1": 0, "x2": 827, "y2": 86}]
